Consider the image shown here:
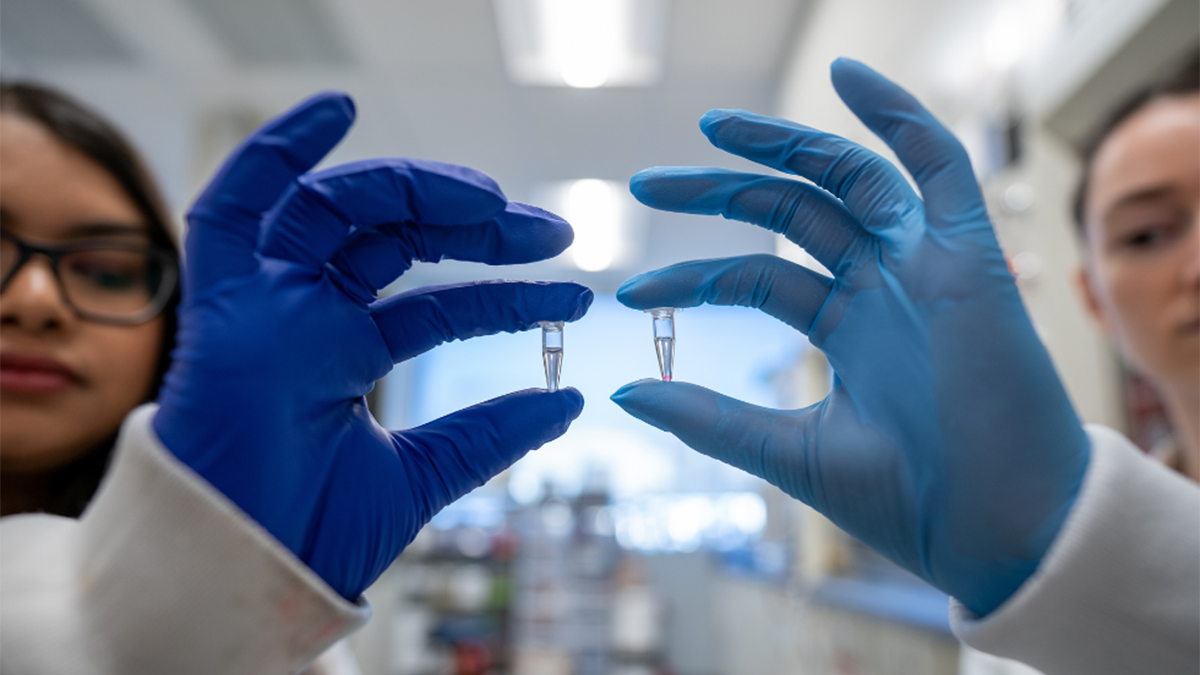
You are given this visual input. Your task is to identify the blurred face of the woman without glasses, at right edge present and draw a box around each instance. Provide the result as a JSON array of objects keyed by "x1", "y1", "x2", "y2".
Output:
[{"x1": 1081, "y1": 94, "x2": 1200, "y2": 387}]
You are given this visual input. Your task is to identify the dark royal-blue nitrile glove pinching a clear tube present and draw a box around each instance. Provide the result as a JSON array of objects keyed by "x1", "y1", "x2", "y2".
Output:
[{"x1": 154, "y1": 94, "x2": 592, "y2": 598}]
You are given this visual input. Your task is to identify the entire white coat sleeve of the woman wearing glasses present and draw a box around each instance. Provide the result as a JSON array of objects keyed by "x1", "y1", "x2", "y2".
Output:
[{"x1": 0, "y1": 406, "x2": 371, "y2": 675}]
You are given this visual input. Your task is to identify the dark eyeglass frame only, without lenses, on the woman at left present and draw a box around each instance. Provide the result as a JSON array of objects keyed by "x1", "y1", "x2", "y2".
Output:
[{"x1": 0, "y1": 228, "x2": 179, "y2": 325}]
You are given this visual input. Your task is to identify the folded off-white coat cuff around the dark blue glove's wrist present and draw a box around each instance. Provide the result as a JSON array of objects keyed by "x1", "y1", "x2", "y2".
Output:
[{"x1": 79, "y1": 405, "x2": 371, "y2": 673}]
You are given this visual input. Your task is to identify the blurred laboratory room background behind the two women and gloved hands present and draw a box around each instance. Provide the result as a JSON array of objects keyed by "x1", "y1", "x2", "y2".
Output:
[{"x1": 0, "y1": 0, "x2": 1200, "y2": 675}]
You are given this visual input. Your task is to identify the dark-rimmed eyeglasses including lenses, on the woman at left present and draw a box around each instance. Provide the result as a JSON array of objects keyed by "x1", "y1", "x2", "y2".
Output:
[{"x1": 0, "y1": 229, "x2": 179, "y2": 325}]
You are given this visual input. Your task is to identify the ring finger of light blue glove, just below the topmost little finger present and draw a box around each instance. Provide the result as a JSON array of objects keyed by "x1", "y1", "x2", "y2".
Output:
[{"x1": 700, "y1": 110, "x2": 923, "y2": 245}]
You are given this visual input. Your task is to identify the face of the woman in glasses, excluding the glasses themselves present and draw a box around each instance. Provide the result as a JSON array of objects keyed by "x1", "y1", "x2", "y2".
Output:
[{"x1": 0, "y1": 113, "x2": 163, "y2": 473}]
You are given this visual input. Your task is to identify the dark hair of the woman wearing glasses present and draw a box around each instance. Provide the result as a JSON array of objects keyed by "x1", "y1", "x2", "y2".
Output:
[{"x1": 0, "y1": 80, "x2": 180, "y2": 518}]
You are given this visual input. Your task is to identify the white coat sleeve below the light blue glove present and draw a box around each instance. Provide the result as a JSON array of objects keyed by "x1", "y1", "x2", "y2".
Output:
[{"x1": 950, "y1": 426, "x2": 1200, "y2": 675}]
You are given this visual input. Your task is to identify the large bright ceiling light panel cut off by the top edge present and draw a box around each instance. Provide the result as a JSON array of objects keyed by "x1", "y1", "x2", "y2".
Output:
[{"x1": 493, "y1": 0, "x2": 667, "y2": 89}]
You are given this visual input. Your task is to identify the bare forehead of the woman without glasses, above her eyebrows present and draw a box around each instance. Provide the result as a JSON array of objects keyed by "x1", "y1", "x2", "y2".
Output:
[{"x1": 1087, "y1": 94, "x2": 1200, "y2": 214}]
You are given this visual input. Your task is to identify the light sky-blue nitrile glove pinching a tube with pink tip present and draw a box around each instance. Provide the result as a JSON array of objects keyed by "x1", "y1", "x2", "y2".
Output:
[{"x1": 613, "y1": 59, "x2": 1090, "y2": 615}]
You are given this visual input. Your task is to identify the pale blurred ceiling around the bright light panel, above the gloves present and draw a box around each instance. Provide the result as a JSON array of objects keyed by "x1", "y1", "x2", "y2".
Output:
[{"x1": 0, "y1": 0, "x2": 806, "y2": 291}]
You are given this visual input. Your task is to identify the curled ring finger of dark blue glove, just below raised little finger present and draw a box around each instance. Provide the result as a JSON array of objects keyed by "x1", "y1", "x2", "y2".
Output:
[{"x1": 262, "y1": 159, "x2": 508, "y2": 270}]
